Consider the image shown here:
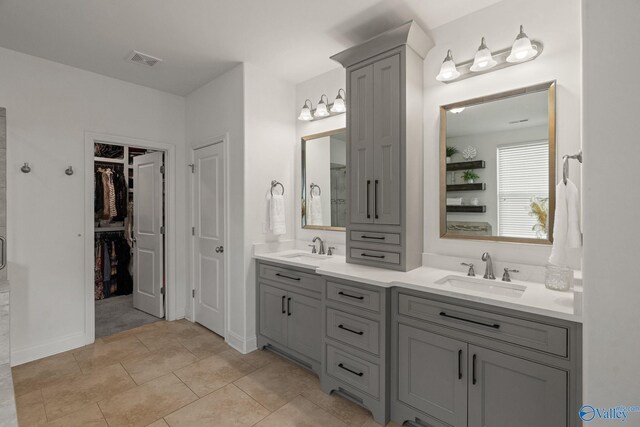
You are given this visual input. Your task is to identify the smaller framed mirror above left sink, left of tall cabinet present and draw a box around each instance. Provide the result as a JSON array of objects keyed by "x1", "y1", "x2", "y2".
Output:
[{"x1": 301, "y1": 128, "x2": 347, "y2": 231}]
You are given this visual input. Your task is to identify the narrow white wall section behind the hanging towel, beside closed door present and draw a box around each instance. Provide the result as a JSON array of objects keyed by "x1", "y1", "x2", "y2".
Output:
[{"x1": 242, "y1": 63, "x2": 300, "y2": 351}]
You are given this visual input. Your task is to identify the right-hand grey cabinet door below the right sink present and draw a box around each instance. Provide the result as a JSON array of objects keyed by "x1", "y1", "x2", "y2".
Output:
[{"x1": 469, "y1": 345, "x2": 567, "y2": 427}]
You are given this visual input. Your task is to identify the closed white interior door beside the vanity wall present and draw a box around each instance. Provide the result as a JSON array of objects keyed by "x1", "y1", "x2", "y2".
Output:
[{"x1": 192, "y1": 143, "x2": 225, "y2": 336}]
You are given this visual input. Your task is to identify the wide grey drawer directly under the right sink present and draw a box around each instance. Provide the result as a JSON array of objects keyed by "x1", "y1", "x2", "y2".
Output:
[{"x1": 398, "y1": 293, "x2": 568, "y2": 357}]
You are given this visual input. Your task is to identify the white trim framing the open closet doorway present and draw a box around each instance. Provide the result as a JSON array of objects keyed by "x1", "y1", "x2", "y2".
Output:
[{"x1": 84, "y1": 131, "x2": 178, "y2": 348}]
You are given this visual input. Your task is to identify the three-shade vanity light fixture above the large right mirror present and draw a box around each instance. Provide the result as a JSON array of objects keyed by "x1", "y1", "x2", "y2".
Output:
[{"x1": 436, "y1": 25, "x2": 544, "y2": 83}]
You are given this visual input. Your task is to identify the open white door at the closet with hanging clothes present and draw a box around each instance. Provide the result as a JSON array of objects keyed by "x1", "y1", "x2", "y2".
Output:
[{"x1": 133, "y1": 152, "x2": 164, "y2": 317}]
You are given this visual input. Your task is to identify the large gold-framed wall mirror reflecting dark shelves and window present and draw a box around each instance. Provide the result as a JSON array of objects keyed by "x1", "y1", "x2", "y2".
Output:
[{"x1": 440, "y1": 82, "x2": 556, "y2": 244}]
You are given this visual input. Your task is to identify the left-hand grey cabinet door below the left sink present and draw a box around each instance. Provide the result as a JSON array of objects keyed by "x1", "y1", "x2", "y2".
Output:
[{"x1": 260, "y1": 283, "x2": 287, "y2": 345}]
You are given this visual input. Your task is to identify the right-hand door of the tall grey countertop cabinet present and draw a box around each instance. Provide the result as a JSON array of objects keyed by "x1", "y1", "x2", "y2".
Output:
[{"x1": 373, "y1": 55, "x2": 400, "y2": 225}]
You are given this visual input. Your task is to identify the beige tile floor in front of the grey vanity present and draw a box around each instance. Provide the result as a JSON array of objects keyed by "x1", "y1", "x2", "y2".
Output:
[{"x1": 13, "y1": 320, "x2": 400, "y2": 427}]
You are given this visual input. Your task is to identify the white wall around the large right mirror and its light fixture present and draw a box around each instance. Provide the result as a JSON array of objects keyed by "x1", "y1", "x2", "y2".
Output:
[{"x1": 424, "y1": 0, "x2": 580, "y2": 265}]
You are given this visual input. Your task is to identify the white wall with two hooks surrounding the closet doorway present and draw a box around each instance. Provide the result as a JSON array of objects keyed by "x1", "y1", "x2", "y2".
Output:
[{"x1": 0, "y1": 48, "x2": 186, "y2": 364}]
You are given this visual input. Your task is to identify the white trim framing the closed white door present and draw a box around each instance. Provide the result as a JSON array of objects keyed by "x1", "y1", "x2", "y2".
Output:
[{"x1": 189, "y1": 132, "x2": 231, "y2": 342}]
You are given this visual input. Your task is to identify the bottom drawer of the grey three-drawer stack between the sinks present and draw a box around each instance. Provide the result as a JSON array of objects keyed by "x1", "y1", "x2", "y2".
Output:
[{"x1": 326, "y1": 345, "x2": 380, "y2": 397}]
